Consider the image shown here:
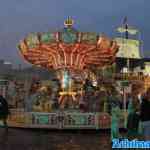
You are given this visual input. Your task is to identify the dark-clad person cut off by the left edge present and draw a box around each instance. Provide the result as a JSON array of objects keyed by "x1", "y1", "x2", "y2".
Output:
[{"x1": 0, "y1": 94, "x2": 9, "y2": 128}]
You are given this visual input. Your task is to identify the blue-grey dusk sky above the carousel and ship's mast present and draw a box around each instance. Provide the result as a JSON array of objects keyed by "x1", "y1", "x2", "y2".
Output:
[{"x1": 0, "y1": 0, "x2": 150, "y2": 66}]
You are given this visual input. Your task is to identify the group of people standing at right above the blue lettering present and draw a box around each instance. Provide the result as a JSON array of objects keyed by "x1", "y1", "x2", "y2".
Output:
[{"x1": 127, "y1": 88, "x2": 150, "y2": 140}]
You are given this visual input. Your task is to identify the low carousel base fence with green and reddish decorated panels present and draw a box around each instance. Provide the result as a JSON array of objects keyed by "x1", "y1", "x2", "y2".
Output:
[{"x1": 4, "y1": 109, "x2": 123, "y2": 130}]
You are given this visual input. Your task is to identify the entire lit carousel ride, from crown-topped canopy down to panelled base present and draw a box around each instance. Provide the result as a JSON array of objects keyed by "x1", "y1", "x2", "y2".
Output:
[{"x1": 3, "y1": 18, "x2": 129, "y2": 129}]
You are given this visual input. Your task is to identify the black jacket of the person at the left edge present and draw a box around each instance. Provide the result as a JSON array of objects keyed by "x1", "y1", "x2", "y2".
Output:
[{"x1": 0, "y1": 96, "x2": 9, "y2": 119}]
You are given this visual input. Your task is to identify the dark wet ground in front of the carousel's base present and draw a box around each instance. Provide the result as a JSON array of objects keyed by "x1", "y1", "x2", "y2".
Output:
[{"x1": 0, "y1": 128, "x2": 111, "y2": 150}]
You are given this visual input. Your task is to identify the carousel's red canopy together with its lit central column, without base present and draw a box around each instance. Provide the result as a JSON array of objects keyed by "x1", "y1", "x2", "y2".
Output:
[{"x1": 14, "y1": 17, "x2": 118, "y2": 129}]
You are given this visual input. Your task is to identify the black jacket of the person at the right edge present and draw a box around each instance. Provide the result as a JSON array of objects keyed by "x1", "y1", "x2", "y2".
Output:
[{"x1": 140, "y1": 98, "x2": 150, "y2": 121}]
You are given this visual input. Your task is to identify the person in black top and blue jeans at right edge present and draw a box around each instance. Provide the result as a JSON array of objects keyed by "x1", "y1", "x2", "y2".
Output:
[{"x1": 140, "y1": 88, "x2": 150, "y2": 140}]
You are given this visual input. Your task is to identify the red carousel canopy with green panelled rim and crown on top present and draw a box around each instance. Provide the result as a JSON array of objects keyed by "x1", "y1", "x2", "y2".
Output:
[{"x1": 19, "y1": 18, "x2": 118, "y2": 70}]
